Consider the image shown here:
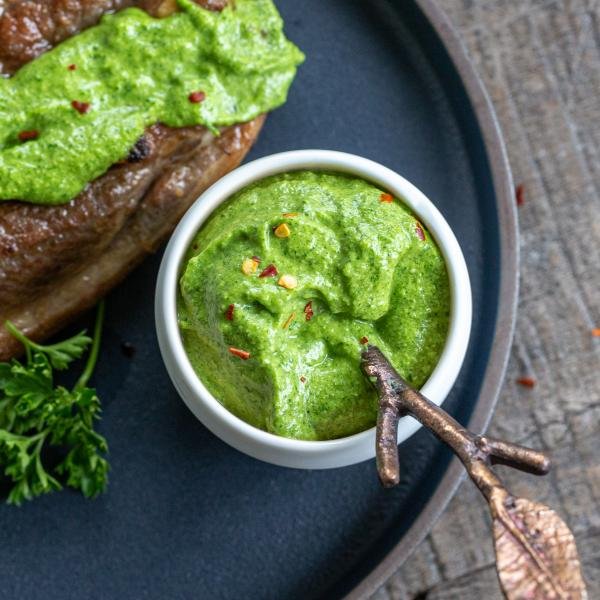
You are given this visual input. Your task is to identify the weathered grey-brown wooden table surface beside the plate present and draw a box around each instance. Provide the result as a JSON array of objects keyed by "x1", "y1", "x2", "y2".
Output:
[{"x1": 372, "y1": 0, "x2": 600, "y2": 600}]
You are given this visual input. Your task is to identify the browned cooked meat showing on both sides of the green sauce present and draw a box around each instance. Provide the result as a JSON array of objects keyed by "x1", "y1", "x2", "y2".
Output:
[{"x1": 0, "y1": 0, "x2": 264, "y2": 360}]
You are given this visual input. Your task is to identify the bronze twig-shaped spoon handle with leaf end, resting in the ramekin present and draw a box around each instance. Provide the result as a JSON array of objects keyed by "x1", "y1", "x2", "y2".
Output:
[{"x1": 362, "y1": 346, "x2": 587, "y2": 600}]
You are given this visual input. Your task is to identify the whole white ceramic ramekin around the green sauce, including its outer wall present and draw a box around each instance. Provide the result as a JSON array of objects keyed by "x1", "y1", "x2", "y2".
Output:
[{"x1": 155, "y1": 150, "x2": 472, "y2": 469}]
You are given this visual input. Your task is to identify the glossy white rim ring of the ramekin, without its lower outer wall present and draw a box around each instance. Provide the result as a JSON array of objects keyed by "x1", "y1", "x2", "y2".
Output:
[{"x1": 156, "y1": 149, "x2": 472, "y2": 455}]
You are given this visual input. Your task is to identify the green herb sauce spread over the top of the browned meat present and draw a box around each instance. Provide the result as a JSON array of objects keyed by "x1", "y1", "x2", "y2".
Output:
[{"x1": 0, "y1": 0, "x2": 304, "y2": 204}]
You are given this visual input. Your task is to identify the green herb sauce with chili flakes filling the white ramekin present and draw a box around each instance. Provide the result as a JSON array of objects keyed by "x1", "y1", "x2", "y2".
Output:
[{"x1": 178, "y1": 171, "x2": 450, "y2": 440}]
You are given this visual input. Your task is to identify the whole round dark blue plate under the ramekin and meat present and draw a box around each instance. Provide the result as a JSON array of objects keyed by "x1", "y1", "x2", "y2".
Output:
[{"x1": 0, "y1": 0, "x2": 517, "y2": 600}]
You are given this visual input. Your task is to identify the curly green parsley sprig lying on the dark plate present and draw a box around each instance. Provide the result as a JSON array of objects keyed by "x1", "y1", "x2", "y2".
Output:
[{"x1": 0, "y1": 302, "x2": 108, "y2": 504}]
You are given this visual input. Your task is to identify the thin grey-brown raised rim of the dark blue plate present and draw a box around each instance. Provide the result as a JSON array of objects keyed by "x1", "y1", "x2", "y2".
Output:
[{"x1": 345, "y1": 0, "x2": 519, "y2": 600}]
